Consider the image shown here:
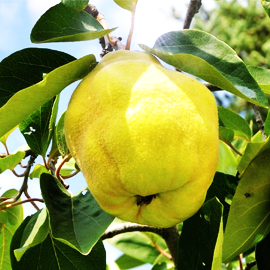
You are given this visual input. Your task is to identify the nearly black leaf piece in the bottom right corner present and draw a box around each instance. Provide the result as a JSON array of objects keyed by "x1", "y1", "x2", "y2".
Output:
[{"x1": 255, "y1": 233, "x2": 270, "y2": 270}]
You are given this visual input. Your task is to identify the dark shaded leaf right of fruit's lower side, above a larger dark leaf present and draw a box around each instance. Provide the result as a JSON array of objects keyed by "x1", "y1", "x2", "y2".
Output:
[{"x1": 205, "y1": 172, "x2": 239, "y2": 227}]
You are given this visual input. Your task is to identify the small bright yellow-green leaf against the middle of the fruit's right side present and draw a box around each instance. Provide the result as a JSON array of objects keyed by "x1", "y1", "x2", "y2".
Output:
[{"x1": 217, "y1": 141, "x2": 237, "y2": 175}]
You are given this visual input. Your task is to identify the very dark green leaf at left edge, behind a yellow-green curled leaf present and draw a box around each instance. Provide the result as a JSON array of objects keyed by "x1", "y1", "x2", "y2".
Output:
[{"x1": 0, "y1": 48, "x2": 76, "y2": 107}]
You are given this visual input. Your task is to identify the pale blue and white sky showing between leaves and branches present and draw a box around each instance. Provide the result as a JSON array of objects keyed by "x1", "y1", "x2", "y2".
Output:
[{"x1": 0, "y1": 0, "x2": 215, "y2": 268}]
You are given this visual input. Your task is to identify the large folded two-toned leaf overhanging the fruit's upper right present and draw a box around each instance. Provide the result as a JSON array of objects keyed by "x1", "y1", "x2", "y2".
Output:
[{"x1": 140, "y1": 30, "x2": 268, "y2": 107}]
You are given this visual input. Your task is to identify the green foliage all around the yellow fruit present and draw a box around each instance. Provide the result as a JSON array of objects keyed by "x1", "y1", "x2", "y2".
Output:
[{"x1": 0, "y1": 0, "x2": 270, "y2": 270}]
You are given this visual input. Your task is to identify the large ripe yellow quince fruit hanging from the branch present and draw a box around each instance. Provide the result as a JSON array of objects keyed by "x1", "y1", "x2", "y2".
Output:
[{"x1": 65, "y1": 51, "x2": 218, "y2": 227}]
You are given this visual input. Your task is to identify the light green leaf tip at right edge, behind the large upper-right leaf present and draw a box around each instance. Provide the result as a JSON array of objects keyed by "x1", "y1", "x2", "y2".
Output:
[{"x1": 248, "y1": 66, "x2": 270, "y2": 94}]
